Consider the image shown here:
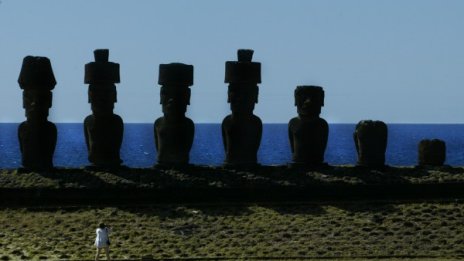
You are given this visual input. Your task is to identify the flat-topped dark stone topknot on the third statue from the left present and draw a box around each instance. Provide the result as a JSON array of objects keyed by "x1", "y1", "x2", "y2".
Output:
[{"x1": 158, "y1": 63, "x2": 193, "y2": 87}]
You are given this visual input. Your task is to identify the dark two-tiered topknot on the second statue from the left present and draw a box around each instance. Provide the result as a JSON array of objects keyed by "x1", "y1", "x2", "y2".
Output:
[{"x1": 84, "y1": 49, "x2": 120, "y2": 84}]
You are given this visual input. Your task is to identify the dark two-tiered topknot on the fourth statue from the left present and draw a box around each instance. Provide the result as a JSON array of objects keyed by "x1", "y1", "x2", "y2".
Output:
[{"x1": 224, "y1": 49, "x2": 261, "y2": 85}]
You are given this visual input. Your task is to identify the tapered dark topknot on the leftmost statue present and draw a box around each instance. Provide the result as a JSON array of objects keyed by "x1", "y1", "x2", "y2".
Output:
[{"x1": 18, "y1": 56, "x2": 56, "y2": 91}]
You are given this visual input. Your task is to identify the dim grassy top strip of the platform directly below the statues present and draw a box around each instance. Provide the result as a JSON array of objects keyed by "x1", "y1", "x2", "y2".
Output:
[{"x1": 0, "y1": 166, "x2": 464, "y2": 188}]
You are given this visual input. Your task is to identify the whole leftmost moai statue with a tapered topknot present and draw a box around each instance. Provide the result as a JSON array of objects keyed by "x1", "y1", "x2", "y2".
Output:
[{"x1": 18, "y1": 56, "x2": 57, "y2": 170}]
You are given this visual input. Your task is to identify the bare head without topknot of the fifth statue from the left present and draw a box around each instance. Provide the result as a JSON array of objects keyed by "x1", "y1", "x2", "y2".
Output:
[{"x1": 295, "y1": 85, "x2": 324, "y2": 118}]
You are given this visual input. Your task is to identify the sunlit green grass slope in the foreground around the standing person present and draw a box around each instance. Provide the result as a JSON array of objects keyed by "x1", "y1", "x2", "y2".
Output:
[{"x1": 0, "y1": 201, "x2": 464, "y2": 260}]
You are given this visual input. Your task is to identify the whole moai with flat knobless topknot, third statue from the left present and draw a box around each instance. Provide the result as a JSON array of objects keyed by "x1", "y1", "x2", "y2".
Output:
[{"x1": 154, "y1": 63, "x2": 195, "y2": 166}]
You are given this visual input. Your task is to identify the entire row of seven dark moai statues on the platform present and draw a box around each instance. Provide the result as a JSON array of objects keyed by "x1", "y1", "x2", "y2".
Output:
[{"x1": 18, "y1": 49, "x2": 446, "y2": 170}]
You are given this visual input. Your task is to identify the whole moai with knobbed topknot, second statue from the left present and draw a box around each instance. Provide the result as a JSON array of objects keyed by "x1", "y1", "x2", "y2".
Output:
[{"x1": 84, "y1": 49, "x2": 124, "y2": 169}]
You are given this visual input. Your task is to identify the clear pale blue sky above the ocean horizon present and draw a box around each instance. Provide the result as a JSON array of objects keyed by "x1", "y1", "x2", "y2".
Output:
[{"x1": 0, "y1": 0, "x2": 464, "y2": 123}]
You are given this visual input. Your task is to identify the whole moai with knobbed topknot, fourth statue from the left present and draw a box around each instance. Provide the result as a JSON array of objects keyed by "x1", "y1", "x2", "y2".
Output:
[{"x1": 222, "y1": 50, "x2": 263, "y2": 167}]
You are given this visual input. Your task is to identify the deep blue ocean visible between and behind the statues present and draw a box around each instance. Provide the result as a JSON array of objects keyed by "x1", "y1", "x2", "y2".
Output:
[{"x1": 0, "y1": 123, "x2": 464, "y2": 169}]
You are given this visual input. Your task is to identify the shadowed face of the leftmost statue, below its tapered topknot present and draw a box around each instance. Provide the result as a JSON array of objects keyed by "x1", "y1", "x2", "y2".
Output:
[{"x1": 23, "y1": 90, "x2": 52, "y2": 120}]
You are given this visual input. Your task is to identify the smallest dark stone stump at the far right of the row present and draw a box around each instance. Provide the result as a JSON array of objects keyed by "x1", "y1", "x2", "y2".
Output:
[{"x1": 419, "y1": 139, "x2": 446, "y2": 166}]
